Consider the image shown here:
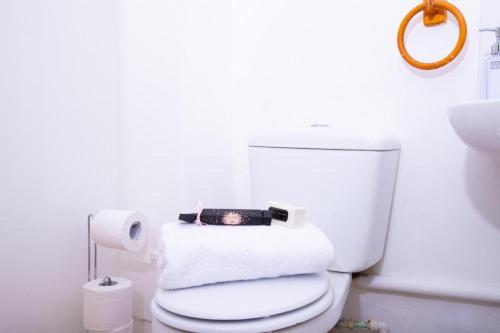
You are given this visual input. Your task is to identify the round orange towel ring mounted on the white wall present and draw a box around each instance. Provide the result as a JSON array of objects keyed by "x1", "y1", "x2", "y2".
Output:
[{"x1": 398, "y1": 0, "x2": 467, "y2": 70}]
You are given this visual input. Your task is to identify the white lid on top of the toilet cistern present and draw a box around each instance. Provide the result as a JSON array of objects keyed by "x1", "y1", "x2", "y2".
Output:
[{"x1": 248, "y1": 127, "x2": 401, "y2": 151}]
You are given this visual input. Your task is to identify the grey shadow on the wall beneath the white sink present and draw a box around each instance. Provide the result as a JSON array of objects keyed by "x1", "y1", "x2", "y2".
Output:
[{"x1": 465, "y1": 150, "x2": 500, "y2": 229}]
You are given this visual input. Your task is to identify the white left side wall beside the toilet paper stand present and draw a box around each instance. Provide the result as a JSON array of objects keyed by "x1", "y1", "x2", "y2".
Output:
[{"x1": 0, "y1": 0, "x2": 119, "y2": 333}]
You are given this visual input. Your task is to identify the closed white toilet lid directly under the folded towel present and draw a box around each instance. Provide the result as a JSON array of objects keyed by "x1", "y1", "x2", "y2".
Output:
[{"x1": 155, "y1": 272, "x2": 330, "y2": 320}]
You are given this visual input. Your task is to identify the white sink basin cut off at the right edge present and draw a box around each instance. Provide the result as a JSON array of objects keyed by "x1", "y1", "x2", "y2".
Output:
[{"x1": 448, "y1": 99, "x2": 500, "y2": 159}]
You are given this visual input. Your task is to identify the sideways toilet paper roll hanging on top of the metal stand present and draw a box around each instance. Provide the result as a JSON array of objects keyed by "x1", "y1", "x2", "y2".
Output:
[{"x1": 90, "y1": 209, "x2": 149, "y2": 251}]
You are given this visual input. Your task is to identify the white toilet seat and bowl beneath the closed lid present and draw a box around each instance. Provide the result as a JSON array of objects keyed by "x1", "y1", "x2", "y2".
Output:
[{"x1": 151, "y1": 272, "x2": 351, "y2": 333}]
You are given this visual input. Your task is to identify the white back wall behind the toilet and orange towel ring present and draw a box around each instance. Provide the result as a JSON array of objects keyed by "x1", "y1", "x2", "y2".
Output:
[{"x1": 118, "y1": 0, "x2": 500, "y2": 332}]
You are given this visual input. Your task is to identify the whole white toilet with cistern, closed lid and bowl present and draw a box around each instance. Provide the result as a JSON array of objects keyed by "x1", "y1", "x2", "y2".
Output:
[{"x1": 151, "y1": 128, "x2": 400, "y2": 333}]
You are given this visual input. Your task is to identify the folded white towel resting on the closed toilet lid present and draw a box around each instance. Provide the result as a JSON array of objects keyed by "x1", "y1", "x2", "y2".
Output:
[{"x1": 158, "y1": 222, "x2": 333, "y2": 289}]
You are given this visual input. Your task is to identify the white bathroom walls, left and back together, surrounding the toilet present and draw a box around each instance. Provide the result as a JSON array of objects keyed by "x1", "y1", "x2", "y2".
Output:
[{"x1": 0, "y1": 0, "x2": 500, "y2": 332}]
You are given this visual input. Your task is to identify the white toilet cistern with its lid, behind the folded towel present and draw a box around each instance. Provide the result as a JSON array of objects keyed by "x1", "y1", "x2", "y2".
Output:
[{"x1": 249, "y1": 128, "x2": 400, "y2": 272}]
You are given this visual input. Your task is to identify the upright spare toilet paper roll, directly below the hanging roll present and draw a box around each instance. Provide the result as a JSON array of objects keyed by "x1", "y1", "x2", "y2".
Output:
[{"x1": 82, "y1": 277, "x2": 132, "y2": 331}]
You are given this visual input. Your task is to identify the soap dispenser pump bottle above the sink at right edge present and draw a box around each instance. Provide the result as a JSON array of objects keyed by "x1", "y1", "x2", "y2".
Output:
[{"x1": 479, "y1": 27, "x2": 500, "y2": 99}]
